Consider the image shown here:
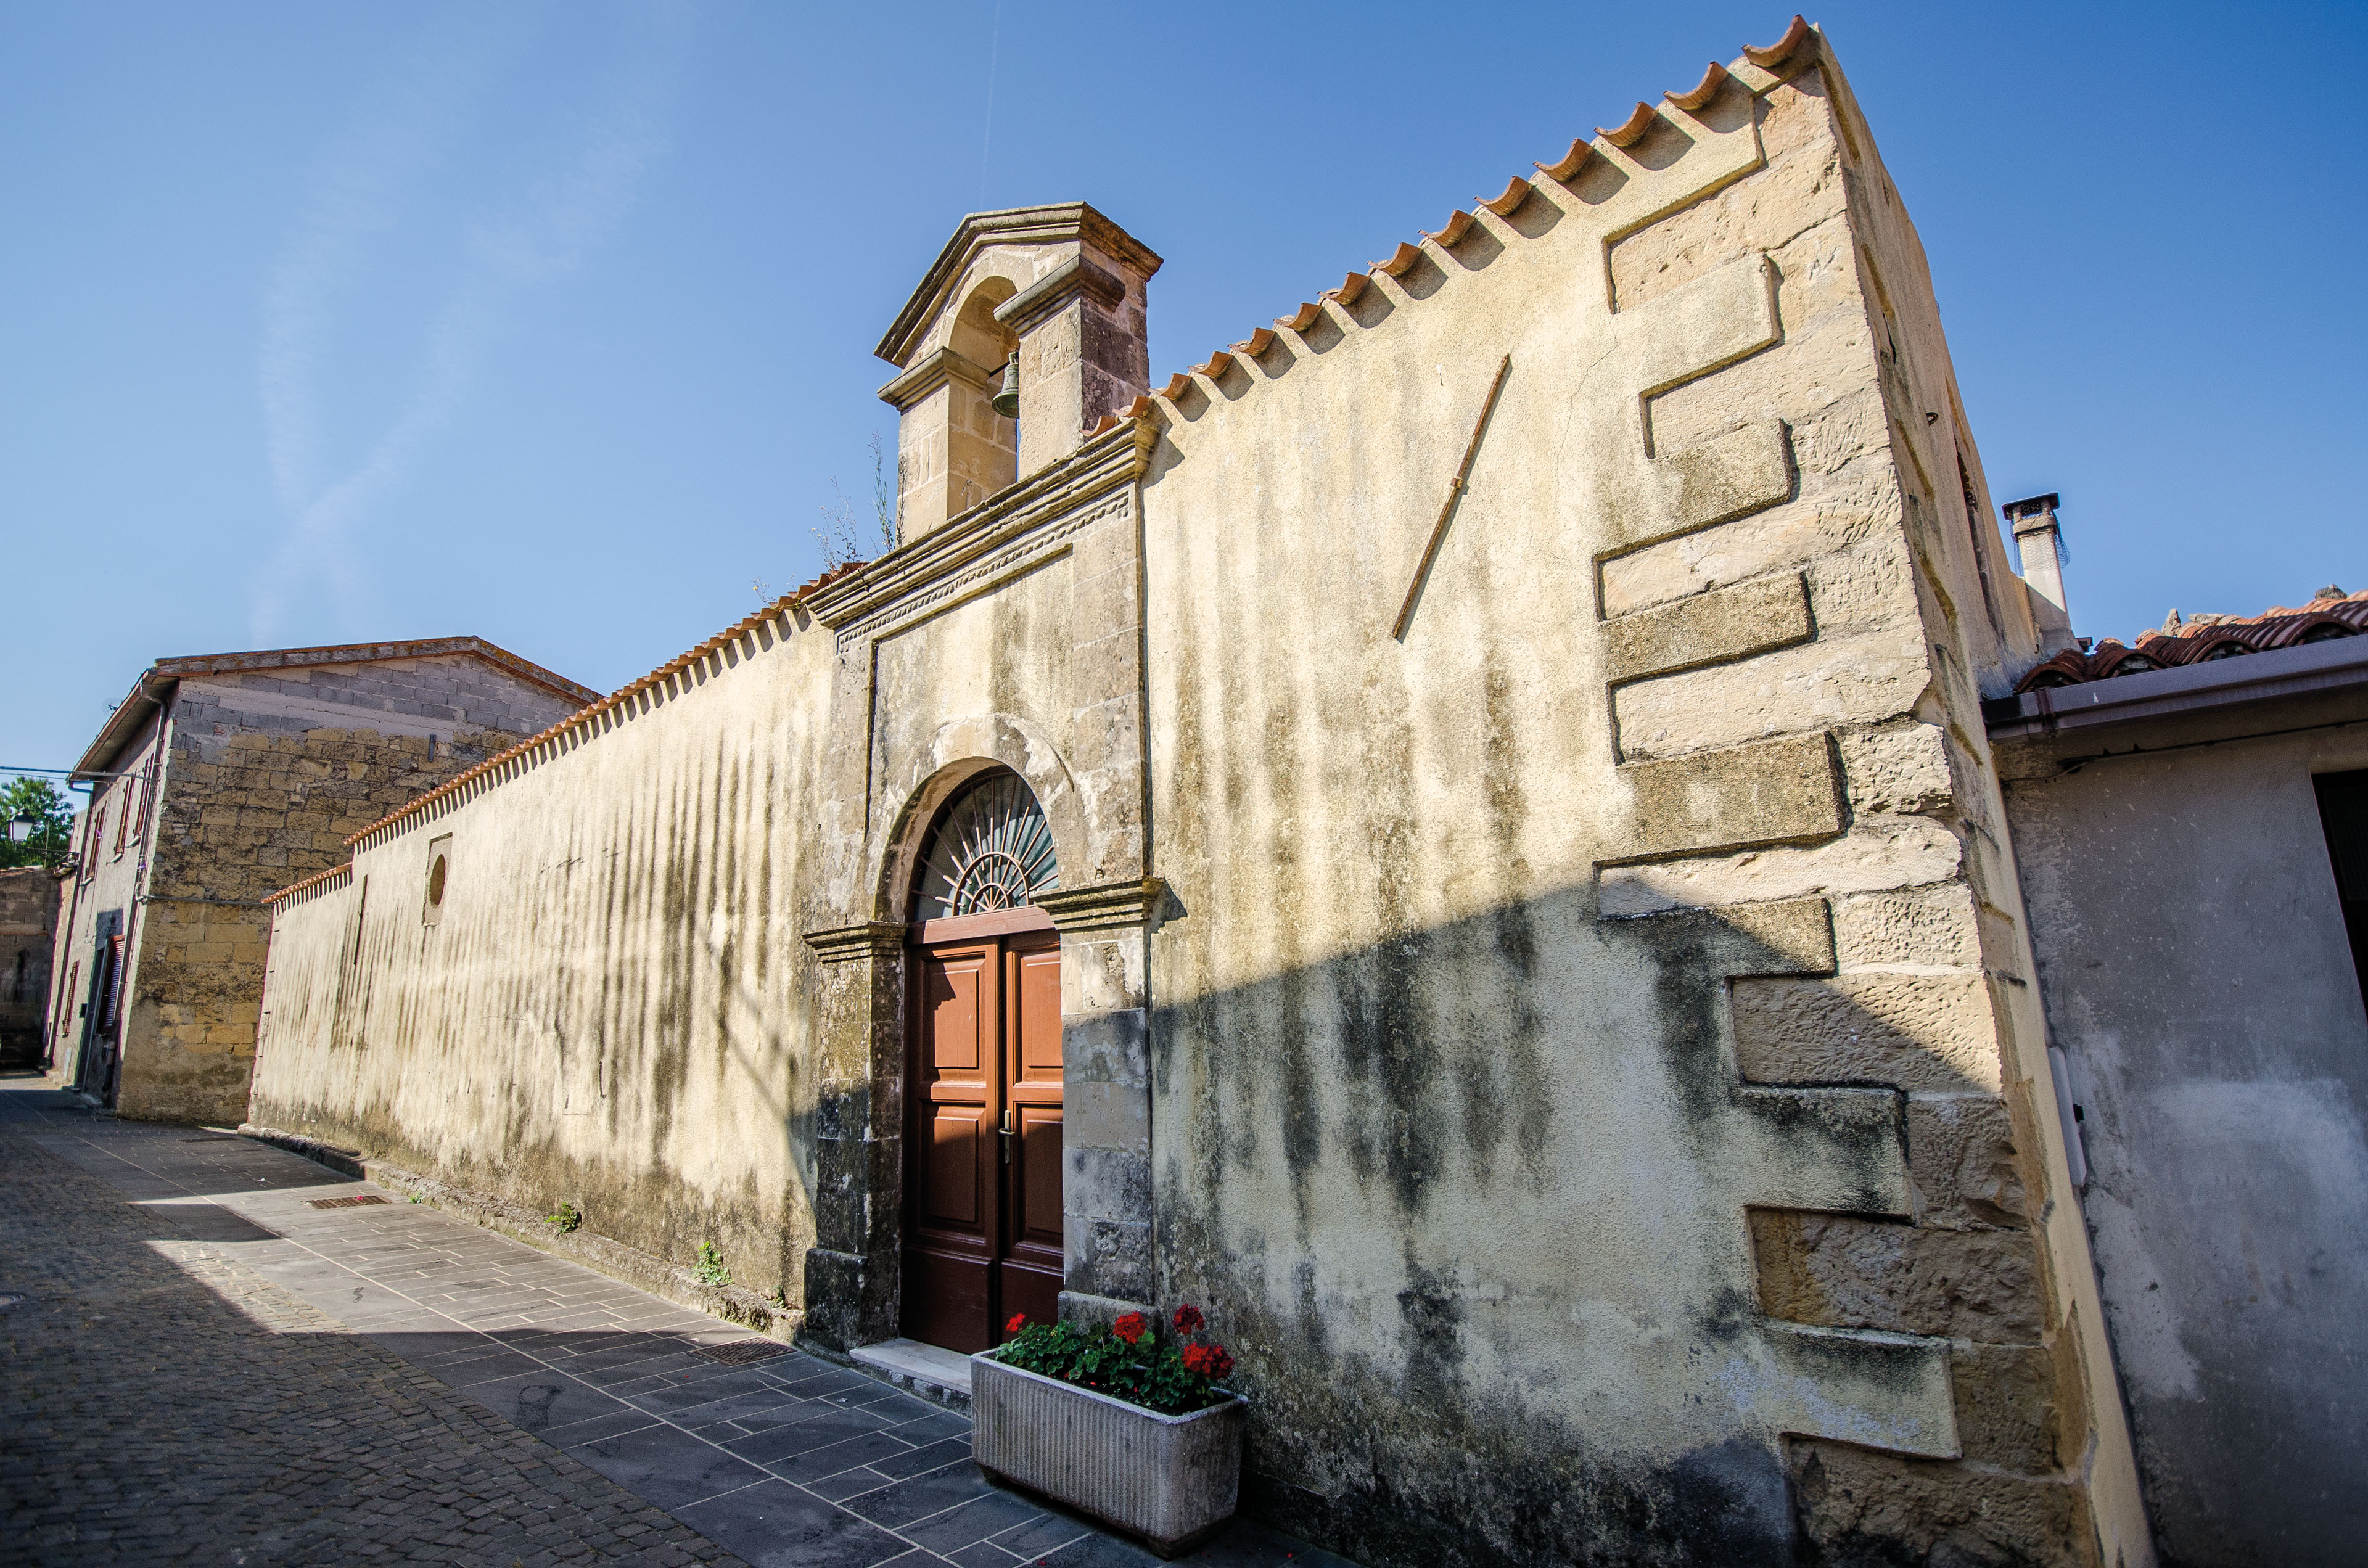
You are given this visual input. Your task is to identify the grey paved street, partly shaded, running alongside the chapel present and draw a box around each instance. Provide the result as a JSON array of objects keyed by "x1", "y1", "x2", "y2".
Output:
[{"x1": 0, "y1": 1080, "x2": 1347, "y2": 1568}]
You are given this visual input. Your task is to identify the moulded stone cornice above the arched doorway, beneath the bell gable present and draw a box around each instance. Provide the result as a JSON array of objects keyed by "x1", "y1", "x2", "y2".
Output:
[{"x1": 805, "y1": 419, "x2": 1158, "y2": 647}]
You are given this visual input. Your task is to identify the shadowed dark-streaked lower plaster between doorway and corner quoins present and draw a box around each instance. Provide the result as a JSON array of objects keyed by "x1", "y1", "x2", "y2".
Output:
[{"x1": 1151, "y1": 889, "x2": 1975, "y2": 1566}]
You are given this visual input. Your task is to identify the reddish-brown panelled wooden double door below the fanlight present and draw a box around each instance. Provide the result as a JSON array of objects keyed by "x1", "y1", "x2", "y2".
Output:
[{"x1": 902, "y1": 921, "x2": 1063, "y2": 1352}]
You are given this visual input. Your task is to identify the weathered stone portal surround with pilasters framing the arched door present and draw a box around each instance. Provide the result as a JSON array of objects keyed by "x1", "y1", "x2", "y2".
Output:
[{"x1": 805, "y1": 419, "x2": 1165, "y2": 1348}]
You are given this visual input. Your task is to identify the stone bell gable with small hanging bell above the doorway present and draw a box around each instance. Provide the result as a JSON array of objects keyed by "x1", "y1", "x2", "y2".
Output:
[{"x1": 876, "y1": 202, "x2": 1161, "y2": 545}]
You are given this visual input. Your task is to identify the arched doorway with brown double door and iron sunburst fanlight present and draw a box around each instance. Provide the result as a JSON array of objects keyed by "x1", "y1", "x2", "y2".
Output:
[{"x1": 902, "y1": 768, "x2": 1063, "y2": 1352}]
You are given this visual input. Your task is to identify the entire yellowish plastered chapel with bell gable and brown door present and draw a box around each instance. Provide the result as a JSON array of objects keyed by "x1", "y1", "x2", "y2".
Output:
[{"x1": 251, "y1": 22, "x2": 2153, "y2": 1568}]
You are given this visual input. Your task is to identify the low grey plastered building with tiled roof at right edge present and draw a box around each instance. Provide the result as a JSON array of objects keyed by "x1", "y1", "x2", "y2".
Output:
[{"x1": 1989, "y1": 588, "x2": 2368, "y2": 1568}]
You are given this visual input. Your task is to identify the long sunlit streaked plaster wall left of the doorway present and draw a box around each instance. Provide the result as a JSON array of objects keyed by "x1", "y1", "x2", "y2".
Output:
[{"x1": 251, "y1": 609, "x2": 831, "y2": 1303}]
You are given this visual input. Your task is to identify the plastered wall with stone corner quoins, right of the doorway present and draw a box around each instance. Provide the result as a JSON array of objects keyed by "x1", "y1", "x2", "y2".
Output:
[{"x1": 1144, "y1": 43, "x2": 2143, "y2": 1563}]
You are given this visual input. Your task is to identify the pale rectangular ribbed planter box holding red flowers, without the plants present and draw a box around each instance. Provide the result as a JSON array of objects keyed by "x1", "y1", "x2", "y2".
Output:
[{"x1": 971, "y1": 1350, "x2": 1243, "y2": 1556}]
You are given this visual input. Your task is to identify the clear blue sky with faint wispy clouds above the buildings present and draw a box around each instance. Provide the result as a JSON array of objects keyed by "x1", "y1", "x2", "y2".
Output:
[{"x1": 0, "y1": 0, "x2": 2368, "y2": 781}]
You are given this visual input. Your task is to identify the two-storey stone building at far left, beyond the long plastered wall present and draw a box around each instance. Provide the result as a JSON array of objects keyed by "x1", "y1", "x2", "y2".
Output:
[{"x1": 50, "y1": 637, "x2": 597, "y2": 1123}]
